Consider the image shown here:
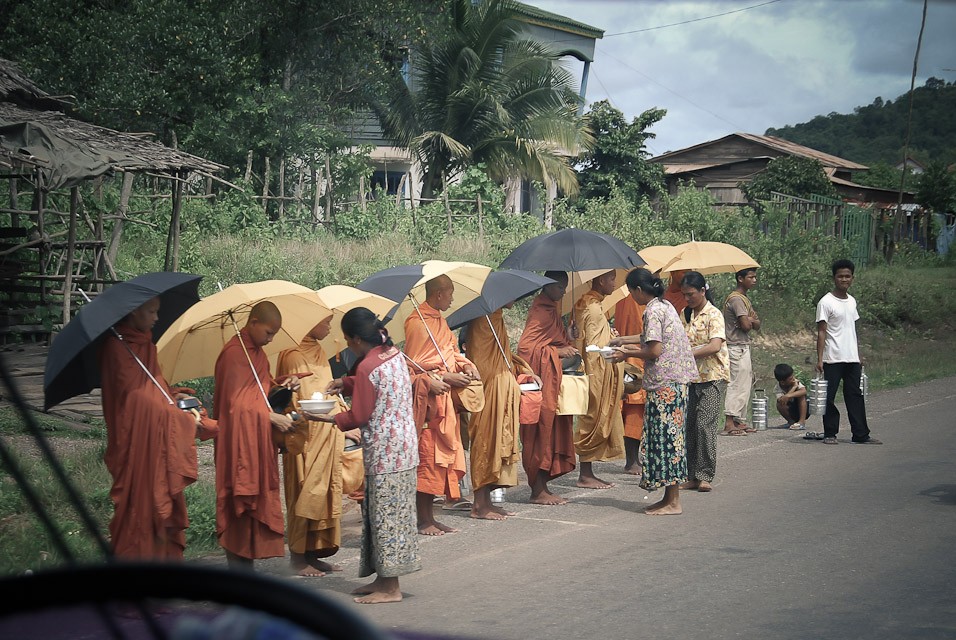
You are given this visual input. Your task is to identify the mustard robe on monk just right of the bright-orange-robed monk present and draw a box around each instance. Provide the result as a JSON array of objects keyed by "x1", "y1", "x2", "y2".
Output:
[{"x1": 465, "y1": 309, "x2": 531, "y2": 489}]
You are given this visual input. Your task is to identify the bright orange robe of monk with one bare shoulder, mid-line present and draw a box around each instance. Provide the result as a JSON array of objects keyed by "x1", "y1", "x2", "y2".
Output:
[{"x1": 405, "y1": 302, "x2": 472, "y2": 500}]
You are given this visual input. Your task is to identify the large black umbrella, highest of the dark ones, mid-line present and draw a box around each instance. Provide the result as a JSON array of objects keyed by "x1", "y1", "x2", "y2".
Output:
[{"x1": 500, "y1": 229, "x2": 646, "y2": 272}]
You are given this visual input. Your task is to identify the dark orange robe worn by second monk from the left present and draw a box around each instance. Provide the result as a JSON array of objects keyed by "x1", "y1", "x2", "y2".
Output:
[{"x1": 213, "y1": 329, "x2": 285, "y2": 559}]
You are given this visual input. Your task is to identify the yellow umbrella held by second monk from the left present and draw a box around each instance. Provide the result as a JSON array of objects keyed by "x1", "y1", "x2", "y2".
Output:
[{"x1": 156, "y1": 280, "x2": 332, "y2": 384}]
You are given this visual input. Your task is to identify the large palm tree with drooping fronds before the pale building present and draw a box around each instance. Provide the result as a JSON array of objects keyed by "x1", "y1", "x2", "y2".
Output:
[{"x1": 376, "y1": 0, "x2": 593, "y2": 198}]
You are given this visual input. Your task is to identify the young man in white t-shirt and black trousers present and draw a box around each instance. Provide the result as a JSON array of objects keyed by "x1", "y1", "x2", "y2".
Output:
[{"x1": 817, "y1": 260, "x2": 883, "y2": 444}]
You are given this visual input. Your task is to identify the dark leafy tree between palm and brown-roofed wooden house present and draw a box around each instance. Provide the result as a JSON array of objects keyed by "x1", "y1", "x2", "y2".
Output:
[{"x1": 578, "y1": 100, "x2": 667, "y2": 200}]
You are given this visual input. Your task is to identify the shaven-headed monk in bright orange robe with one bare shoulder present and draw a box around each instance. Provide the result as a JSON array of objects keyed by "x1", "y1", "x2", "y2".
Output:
[{"x1": 405, "y1": 275, "x2": 480, "y2": 536}]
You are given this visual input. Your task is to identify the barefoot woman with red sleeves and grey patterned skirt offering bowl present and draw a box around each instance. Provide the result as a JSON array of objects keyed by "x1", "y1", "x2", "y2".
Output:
[{"x1": 306, "y1": 307, "x2": 421, "y2": 604}]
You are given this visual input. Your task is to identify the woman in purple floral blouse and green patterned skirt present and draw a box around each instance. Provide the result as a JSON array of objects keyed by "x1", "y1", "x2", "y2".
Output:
[{"x1": 610, "y1": 267, "x2": 697, "y2": 516}]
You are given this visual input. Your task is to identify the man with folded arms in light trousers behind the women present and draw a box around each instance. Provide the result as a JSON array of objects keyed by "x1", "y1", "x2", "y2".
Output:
[{"x1": 720, "y1": 267, "x2": 760, "y2": 436}]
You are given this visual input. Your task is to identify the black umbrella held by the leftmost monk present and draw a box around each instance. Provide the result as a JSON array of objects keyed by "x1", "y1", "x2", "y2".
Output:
[{"x1": 43, "y1": 271, "x2": 202, "y2": 409}]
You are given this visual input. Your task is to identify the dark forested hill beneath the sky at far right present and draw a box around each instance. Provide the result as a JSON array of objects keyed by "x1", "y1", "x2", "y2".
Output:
[{"x1": 767, "y1": 78, "x2": 956, "y2": 166}]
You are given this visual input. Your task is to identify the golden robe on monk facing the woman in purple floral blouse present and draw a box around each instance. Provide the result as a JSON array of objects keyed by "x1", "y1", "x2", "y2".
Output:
[{"x1": 574, "y1": 289, "x2": 624, "y2": 462}]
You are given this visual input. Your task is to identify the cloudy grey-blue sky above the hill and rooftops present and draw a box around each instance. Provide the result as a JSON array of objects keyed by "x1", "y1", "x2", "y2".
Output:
[{"x1": 525, "y1": 0, "x2": 956, "y2": 155}]
